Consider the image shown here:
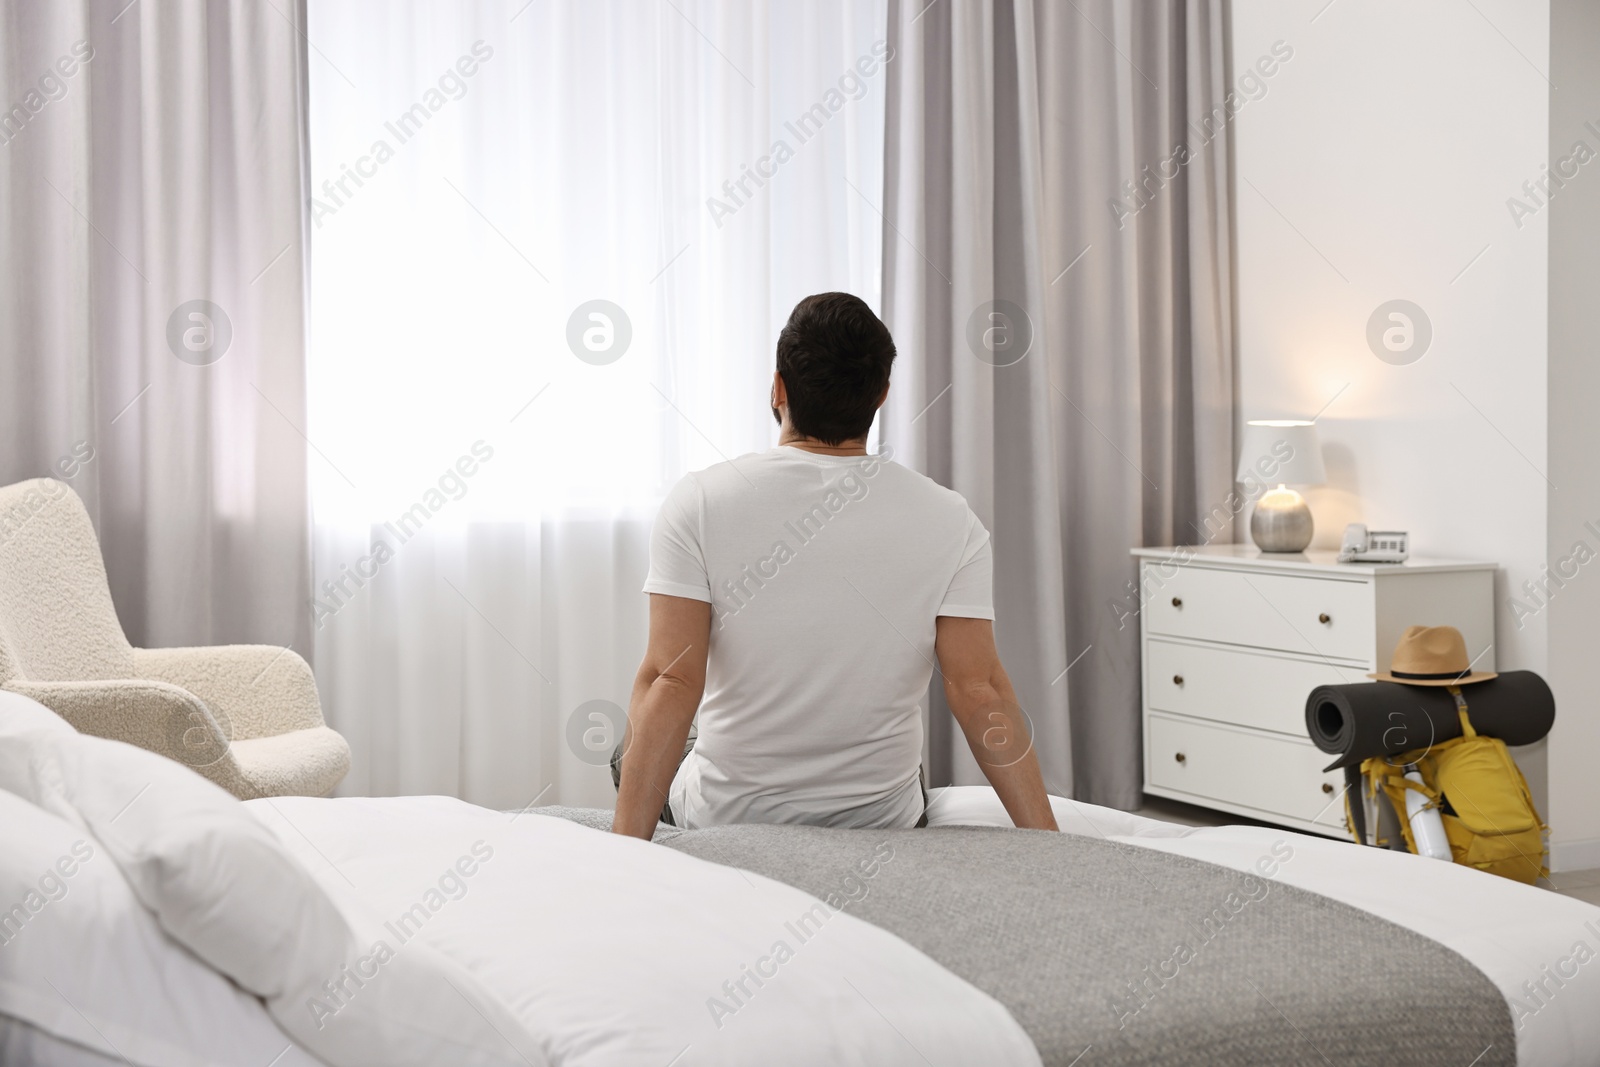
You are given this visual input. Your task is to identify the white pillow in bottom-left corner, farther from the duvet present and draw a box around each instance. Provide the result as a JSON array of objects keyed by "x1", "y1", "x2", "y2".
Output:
[{"x1": 0, "y1": 783, "x2": 315, "y2": 1067}]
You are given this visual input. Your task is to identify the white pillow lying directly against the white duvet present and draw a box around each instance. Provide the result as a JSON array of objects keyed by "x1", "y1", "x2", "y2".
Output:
[{"x1": 0, "y1": 705, "x2": 542, "y2": 1067}]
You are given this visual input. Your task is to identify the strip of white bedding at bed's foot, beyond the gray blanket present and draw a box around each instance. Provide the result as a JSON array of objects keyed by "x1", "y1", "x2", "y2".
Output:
[{"x1": 928, "y1": 785, "x2": 1600, "y2": 1067}]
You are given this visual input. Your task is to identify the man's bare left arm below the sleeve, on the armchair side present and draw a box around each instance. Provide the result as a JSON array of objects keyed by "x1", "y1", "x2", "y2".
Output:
[{"x1": 611, "y1": 593, "x2": 710, "y2": 841}]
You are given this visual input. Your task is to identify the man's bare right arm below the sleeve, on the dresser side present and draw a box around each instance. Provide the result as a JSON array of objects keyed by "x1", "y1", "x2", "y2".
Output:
[{"x1": 933, "y1": 616, "x2": 1058, "y2": 830}]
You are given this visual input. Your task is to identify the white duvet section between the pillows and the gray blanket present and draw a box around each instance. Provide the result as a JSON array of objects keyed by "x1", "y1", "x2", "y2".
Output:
[{"x1": 246, "y1": 797, "x2": 1038, "y2": 1067}]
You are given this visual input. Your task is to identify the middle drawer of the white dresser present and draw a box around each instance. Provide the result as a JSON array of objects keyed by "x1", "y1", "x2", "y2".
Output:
[{"x1": 1144, "y1": 638, "x2": 1366, "y2": 739}]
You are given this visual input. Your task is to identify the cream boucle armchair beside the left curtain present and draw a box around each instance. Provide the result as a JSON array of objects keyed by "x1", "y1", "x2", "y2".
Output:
[{"x1": 0, "y1": 478, "x2": 350, "y2": 800}]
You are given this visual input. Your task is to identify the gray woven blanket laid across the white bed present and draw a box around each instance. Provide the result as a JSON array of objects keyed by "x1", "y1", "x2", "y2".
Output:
[{"x1": 539, "y1": 808, "x2": 1517, "y2": 1067}]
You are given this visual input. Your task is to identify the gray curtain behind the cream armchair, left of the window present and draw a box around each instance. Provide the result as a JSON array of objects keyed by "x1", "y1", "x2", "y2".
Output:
[{"x1": 0, "y1": 0, "x2": 312, "y2": 656}]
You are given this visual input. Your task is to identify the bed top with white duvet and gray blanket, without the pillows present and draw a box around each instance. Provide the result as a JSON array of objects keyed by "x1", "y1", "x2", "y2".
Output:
[{"x1": 37, "y1": 789, "x2": 1574, "y2": 1067}]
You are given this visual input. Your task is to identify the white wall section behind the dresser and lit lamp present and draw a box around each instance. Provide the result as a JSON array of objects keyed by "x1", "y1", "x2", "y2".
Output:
[{"x1": 1232, "y1": 0, "x2": 1555, "y2": 831}]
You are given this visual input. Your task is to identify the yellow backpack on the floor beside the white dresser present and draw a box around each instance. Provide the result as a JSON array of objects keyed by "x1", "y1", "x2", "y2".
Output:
[{"x1": 1362, "y1": 686, "x2": 1550, "y2": 885}]
